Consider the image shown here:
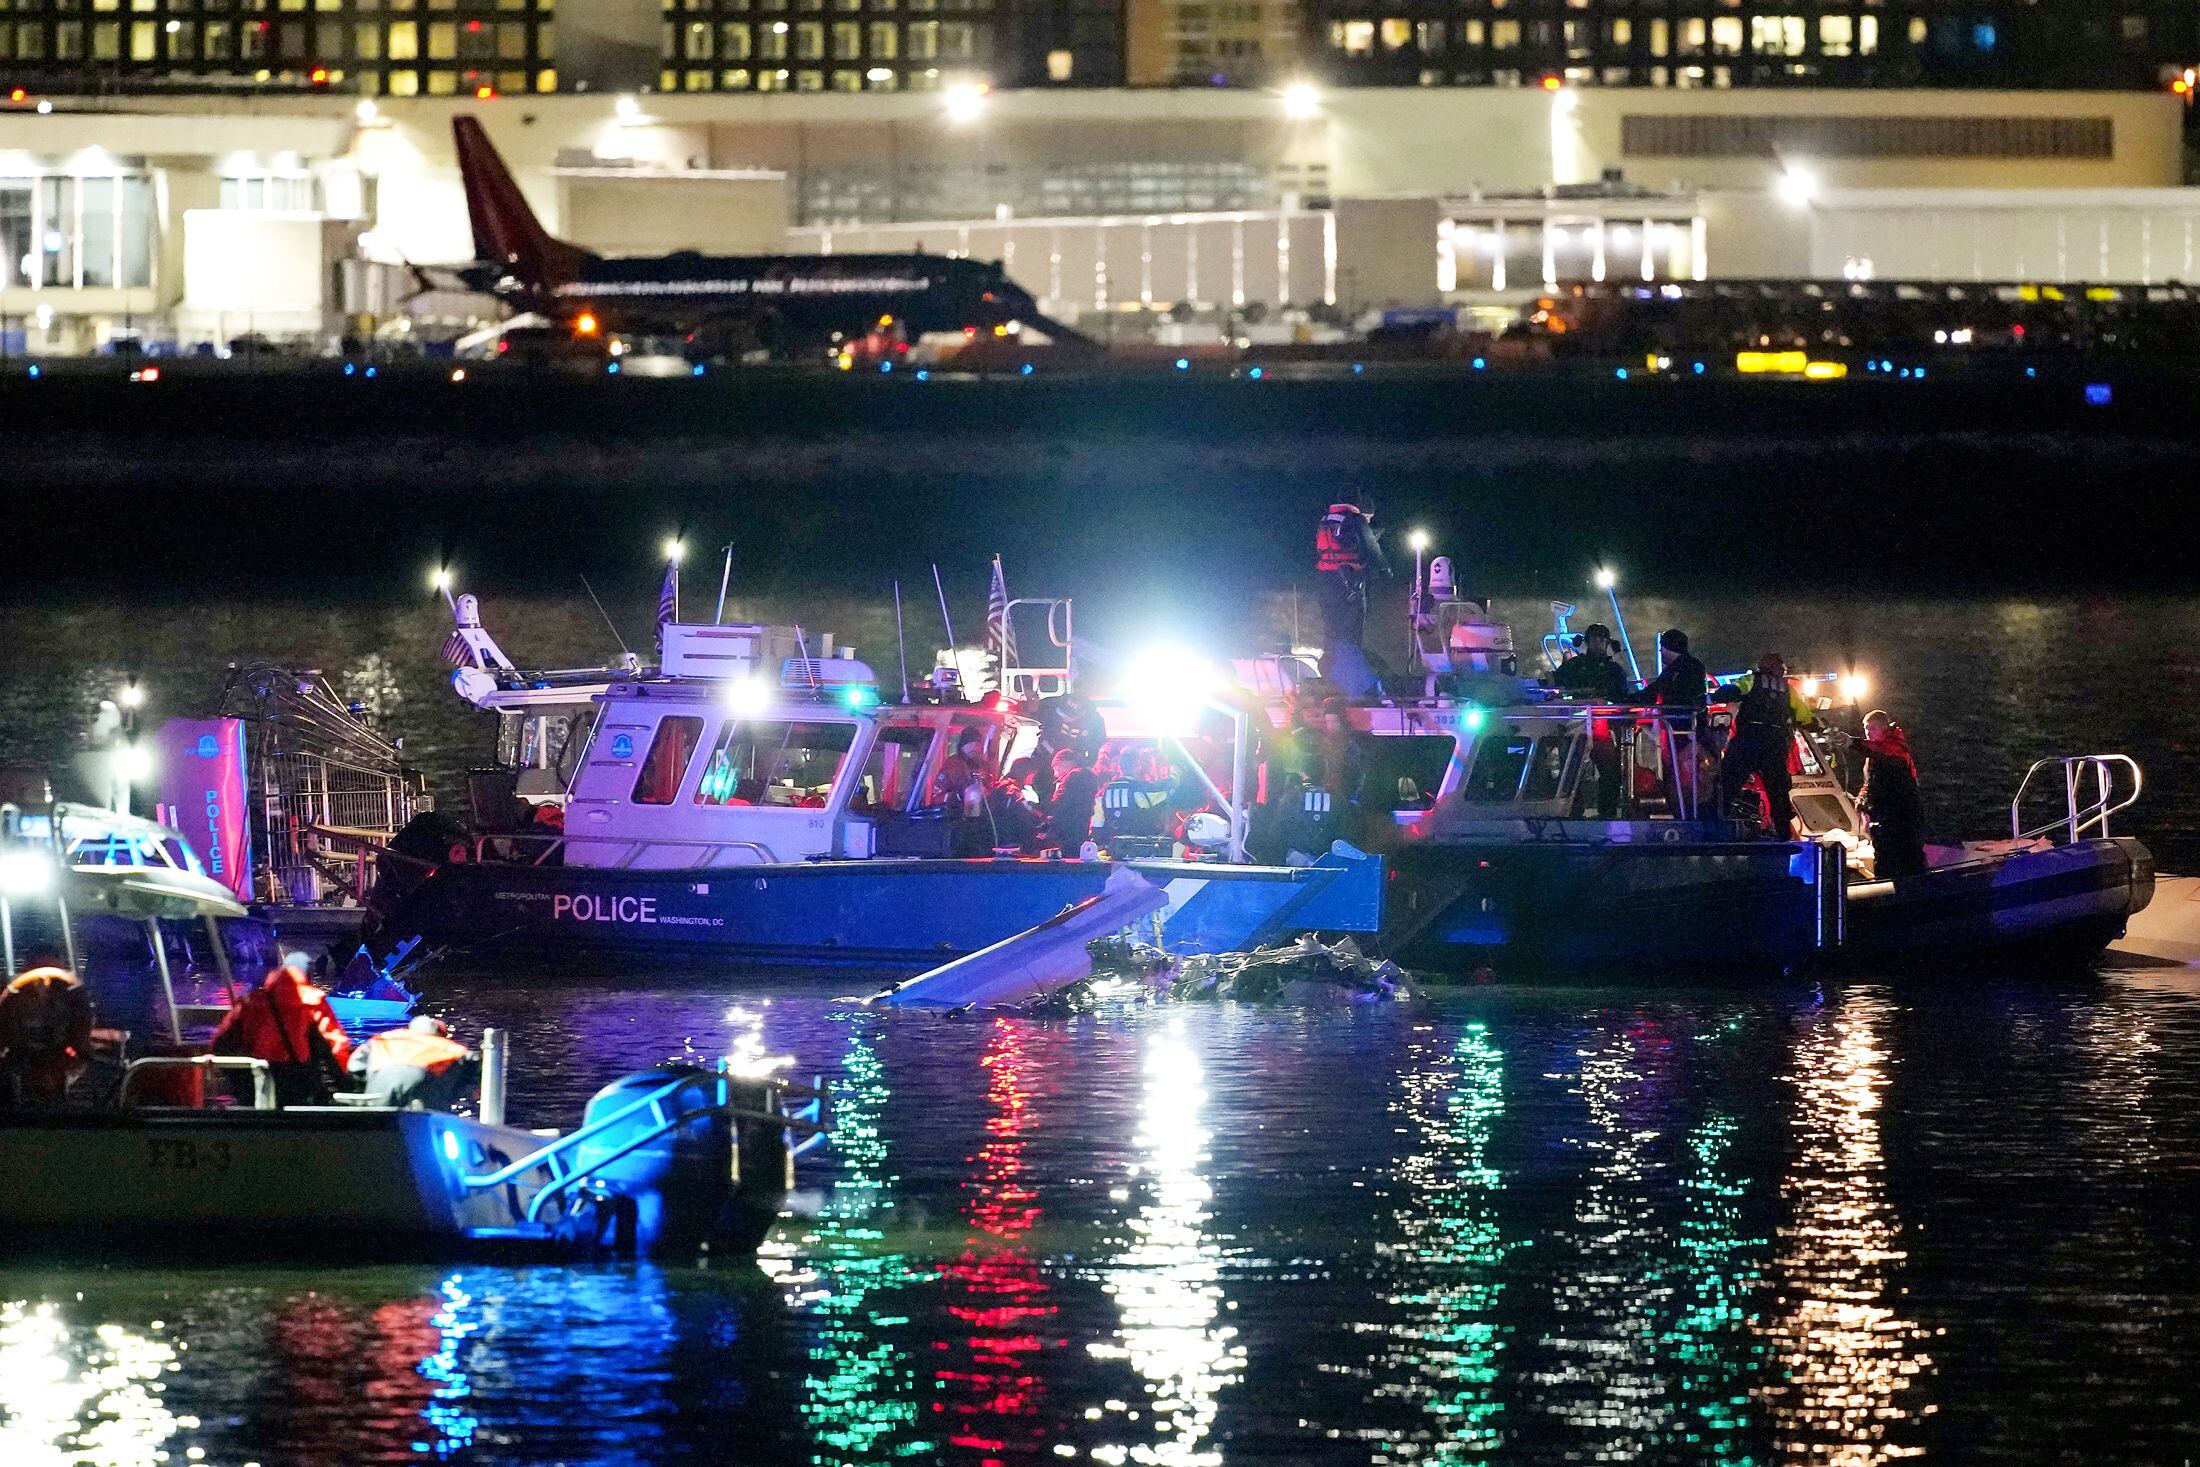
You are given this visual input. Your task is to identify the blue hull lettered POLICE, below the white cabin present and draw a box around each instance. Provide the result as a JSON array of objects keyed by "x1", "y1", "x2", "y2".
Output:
[{"x1": 383, "y1": 853, "x2": 1384, "y2": 972}]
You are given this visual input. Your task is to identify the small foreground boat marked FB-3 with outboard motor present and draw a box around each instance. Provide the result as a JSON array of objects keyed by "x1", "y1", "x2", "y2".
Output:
[{"x1": 0, "y1": 1034, "x2": 825, "y2": 1258}]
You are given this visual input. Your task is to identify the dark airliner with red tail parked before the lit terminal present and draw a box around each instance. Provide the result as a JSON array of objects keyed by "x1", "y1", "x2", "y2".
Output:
[{"x1": 451, "y1": 117, "x2": 1085, "y2": 354}]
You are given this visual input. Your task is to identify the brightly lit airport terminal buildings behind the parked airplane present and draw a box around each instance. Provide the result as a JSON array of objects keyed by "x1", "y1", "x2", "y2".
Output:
[{"x1": 0, "y1": 0, "x2": 2200, "y2": 352}]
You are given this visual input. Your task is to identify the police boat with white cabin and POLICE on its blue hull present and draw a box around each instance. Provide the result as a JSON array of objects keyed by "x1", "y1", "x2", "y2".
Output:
[{"x1": 372, "y1": 596, "x2": 1384, "y2": 972}]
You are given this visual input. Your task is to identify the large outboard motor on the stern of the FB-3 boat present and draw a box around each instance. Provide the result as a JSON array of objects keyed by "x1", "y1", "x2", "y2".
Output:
[{"x1": 574, "y1": 1065, "x2": 794, "y2": 1254}]
